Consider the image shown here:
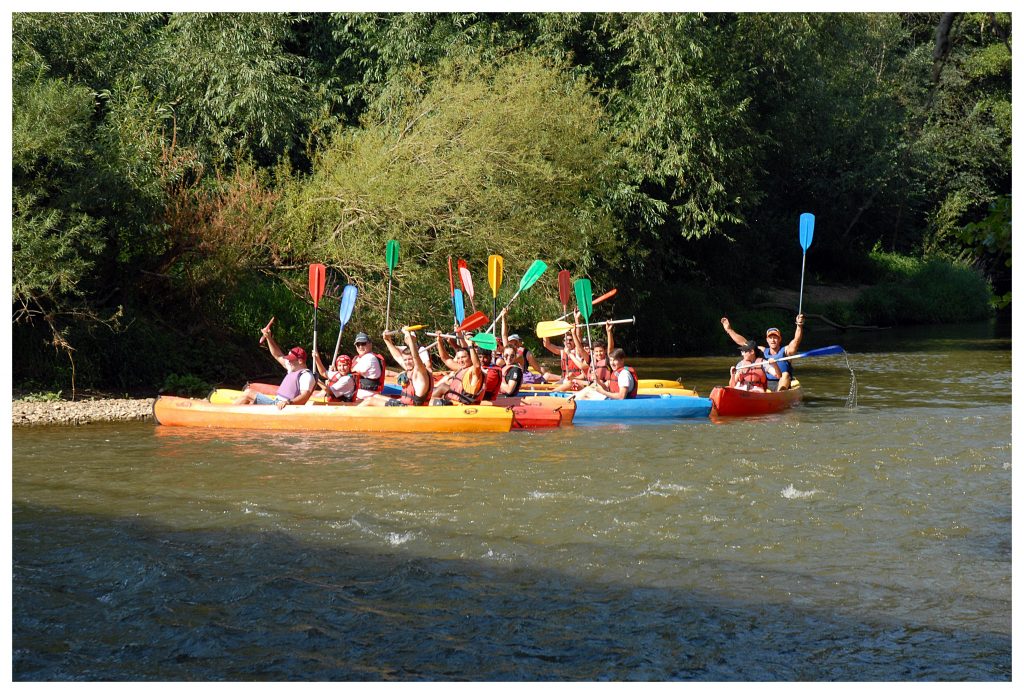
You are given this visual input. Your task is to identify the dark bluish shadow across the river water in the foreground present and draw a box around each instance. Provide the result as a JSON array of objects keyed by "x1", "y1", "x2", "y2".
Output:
[{"x1": 12, "y1": 504, "x2": 1011, "y2": 681}]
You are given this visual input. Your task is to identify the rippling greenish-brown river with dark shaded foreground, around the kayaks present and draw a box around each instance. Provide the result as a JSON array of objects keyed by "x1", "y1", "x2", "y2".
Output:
[{"x1": 12, "y1": 324, "x2": 1012, "y2": 681}]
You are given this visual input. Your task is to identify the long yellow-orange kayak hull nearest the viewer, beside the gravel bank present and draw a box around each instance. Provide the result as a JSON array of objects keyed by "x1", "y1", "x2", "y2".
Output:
[{"x1": 153, "y1": 395, "x2": 514, "y2": 433}]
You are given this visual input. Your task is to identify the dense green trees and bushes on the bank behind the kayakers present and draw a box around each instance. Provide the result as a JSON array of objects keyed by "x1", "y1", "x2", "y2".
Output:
[{"x1": 12, "y1": 13, "x2": 1012, "y2": 392}]
